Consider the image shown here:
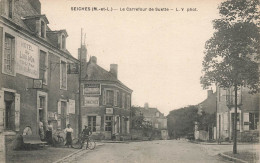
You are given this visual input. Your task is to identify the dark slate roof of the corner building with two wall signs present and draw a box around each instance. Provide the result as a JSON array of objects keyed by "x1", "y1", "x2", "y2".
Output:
[{"x1": 82, "y1": 61, "x2": 132, "y2": 92}]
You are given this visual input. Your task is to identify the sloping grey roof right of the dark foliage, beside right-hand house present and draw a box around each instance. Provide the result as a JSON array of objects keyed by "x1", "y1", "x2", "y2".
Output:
[{"x1": 199, "y1": 92, "x2": 217, "y2": 114}]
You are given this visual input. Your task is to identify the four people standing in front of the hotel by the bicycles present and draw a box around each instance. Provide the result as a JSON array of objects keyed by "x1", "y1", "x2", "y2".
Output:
[{"x1": 39, "y1": 121, "x2": 92, "y2": 147}]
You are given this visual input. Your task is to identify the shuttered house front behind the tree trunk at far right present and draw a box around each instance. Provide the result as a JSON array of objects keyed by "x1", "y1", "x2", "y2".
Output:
[{"x1": 217, "y1": 87, "x2": 260, "y2": 141}]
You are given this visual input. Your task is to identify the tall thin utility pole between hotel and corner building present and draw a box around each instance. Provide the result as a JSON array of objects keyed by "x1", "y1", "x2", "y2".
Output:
[{"x1": 78, "y1": 28, "x2": 82, "y2": 135}]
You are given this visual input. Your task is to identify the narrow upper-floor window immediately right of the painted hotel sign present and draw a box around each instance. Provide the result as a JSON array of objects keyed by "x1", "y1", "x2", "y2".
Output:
[{"x1": 40, "y1": 51, "x2": 47, "y2": 84}]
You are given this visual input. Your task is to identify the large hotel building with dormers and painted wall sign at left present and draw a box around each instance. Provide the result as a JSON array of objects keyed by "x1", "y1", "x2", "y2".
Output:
[{"x1": 0, "y1": 0, "x2": 79, "y2": 146}]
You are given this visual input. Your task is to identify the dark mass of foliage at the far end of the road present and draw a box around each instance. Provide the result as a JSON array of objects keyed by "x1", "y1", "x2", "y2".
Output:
[{"x1": 167, "y1": 105, "x2": 199, "y2": 138}]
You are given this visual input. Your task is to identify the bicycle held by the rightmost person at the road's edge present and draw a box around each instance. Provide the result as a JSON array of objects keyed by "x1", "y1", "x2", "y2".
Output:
[{"x1": 71, "y1": 136, "x2": 96, "y2": 150}]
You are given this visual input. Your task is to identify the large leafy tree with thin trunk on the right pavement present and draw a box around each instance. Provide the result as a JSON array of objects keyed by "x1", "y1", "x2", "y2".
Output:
[{"x1": 201, "y1": 0, "x2": 260, "y2": 154}]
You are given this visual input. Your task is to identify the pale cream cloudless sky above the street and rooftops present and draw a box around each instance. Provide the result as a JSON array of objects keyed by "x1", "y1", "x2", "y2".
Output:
[{"x1": 40, "y1": 0, "x2": 221, "y2": 115}]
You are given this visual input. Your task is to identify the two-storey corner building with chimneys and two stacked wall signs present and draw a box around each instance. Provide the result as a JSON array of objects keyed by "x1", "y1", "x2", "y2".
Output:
[{"x1": 81, "y1": 52, "x2": 132, "y2": 139}]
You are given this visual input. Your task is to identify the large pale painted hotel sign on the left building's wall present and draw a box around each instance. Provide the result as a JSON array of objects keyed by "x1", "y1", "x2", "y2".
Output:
[{"x1": 16, "y1": 37, "x2": 39, "y2": 79}]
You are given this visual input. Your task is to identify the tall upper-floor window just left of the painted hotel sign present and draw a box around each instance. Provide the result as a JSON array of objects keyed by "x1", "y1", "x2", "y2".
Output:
[{"x1": 3, "y1": 34, "x2": 15, "y2": 75}]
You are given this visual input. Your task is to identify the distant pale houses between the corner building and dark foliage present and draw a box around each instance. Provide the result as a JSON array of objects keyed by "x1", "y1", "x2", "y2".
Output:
[{"x1": 133, "y1": 103, "x2": 168, "y2": 139}]
